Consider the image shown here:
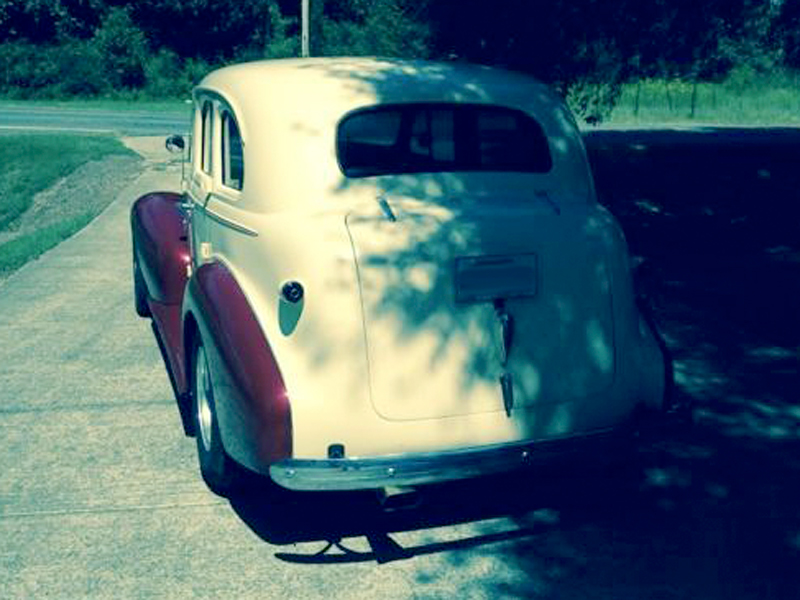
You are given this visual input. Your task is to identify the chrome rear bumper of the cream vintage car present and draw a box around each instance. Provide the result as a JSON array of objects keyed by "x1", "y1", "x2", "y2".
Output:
[{"x1": 269, "y1": 428, "x2": 632, "y2": 491}]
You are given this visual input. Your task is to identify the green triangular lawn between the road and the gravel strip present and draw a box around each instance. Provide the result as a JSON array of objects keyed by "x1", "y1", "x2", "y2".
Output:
[{"x1": 0, "y1": 134, "x2": 133, "y2": 231}]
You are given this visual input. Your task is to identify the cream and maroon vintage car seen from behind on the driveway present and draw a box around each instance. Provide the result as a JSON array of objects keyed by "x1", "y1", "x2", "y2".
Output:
[{"x1": 131, "y1": 58, "x2": 671, "y2": 494}]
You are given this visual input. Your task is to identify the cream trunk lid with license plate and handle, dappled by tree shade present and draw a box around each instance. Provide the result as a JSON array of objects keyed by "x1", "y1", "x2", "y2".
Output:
[{"x1": 346, "y1": 198, "x2": 615, "y2": 420}]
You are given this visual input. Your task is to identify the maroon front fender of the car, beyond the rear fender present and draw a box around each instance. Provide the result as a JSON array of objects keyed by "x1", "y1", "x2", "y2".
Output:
[{"x1": 131, "y1": 192, "x2": 191, "y2": 305}]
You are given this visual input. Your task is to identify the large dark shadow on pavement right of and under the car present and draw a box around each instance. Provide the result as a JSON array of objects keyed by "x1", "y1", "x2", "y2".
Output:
[{"x1": 238, "y1": 130, "x2": 800, "y2": 600}]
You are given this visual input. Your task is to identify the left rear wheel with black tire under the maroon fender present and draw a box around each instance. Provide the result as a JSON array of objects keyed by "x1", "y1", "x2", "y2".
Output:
[{"x1": 191, "y1": 333, "x2": 239, "y2": 498}]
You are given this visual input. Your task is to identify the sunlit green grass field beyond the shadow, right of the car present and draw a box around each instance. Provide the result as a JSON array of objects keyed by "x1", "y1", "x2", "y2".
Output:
[{"x1": 605, "y1": 72, "x2": 800, "y2": 126}]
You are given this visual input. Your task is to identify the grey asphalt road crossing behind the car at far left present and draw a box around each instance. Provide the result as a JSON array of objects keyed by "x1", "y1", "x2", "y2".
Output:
[{"x1": 0, "y1": 107, "x2": 189, "y2": 136}]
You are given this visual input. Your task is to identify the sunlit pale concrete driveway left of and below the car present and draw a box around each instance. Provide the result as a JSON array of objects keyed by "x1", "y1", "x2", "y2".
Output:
[{"x1": 0, "y1": 138, "x2": 552, "y2": 599}]
